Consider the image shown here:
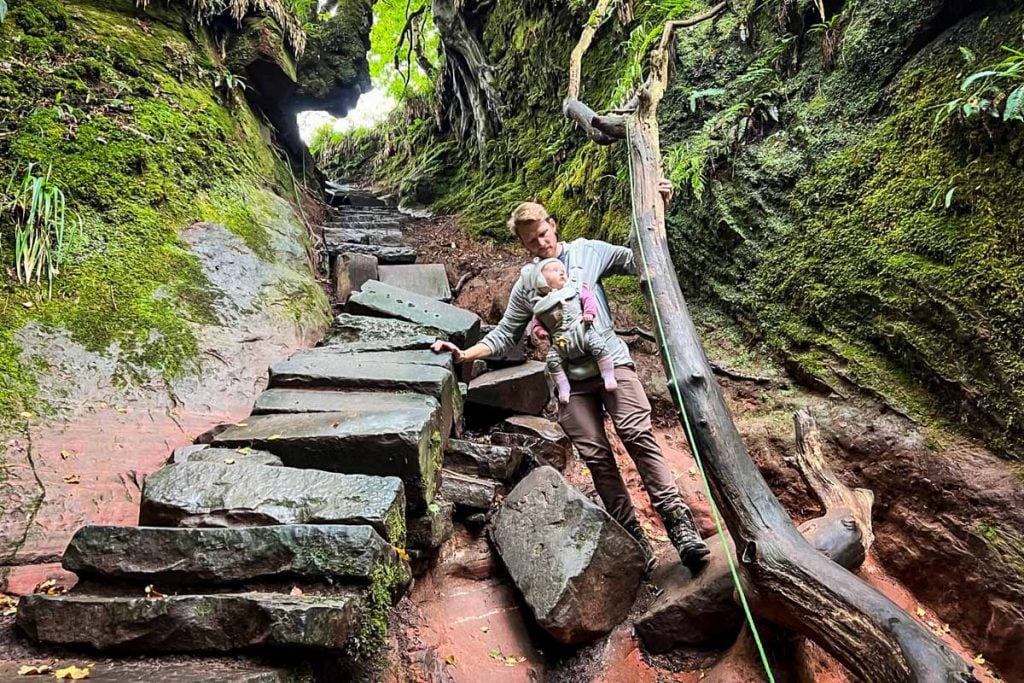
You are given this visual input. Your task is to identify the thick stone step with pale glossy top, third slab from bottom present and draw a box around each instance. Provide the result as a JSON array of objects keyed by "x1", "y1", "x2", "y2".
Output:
[{"x1": 138, "y1": 463, "x2": 406, "y2": 547}]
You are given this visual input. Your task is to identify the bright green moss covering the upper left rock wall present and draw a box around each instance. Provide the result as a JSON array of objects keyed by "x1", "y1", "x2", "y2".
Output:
[{"x1": 0, "y1": 0, "x2": 321, "y2": 424}]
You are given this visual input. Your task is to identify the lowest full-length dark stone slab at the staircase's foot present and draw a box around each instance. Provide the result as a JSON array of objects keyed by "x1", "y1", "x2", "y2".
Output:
[{"x1": 16, "y1": 591, "x2": 367, "y2": 652}]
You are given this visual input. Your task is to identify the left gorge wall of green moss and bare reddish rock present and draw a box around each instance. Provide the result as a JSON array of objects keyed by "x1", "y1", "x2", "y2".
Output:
[{"x1": 0, "y1": 0, "x2": 371, "y2": 592}]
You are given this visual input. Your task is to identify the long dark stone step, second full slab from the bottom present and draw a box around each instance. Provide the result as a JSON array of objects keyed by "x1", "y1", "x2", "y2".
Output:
[{"x1": 62, "y1": 524, "x2": 408, "y2": 587}]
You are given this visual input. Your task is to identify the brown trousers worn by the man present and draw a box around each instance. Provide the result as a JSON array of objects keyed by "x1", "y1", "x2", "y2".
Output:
[{"x1": 558, "y1": 367, "x2": 684, "y2": 526}]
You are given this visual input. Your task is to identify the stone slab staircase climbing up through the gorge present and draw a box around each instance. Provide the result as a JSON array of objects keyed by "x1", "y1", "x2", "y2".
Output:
[{"x1": 9, "y1": 185, "x2": 567, "y2": 681}]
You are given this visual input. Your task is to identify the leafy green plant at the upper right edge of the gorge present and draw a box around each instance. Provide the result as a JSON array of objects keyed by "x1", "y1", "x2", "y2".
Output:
[{"x1": 935, "y1": 45, "x2": 1024, "y2": 128}]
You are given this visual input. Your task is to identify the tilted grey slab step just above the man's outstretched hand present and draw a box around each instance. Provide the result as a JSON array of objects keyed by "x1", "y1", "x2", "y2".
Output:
[{"x1": 348, "y1": 282, "x2": 480, "y2": 348}]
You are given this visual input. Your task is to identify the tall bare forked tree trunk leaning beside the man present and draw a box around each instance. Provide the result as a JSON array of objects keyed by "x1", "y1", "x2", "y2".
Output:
[{"x1": 569, "y1": 0, "x2": 977, "y2": 683}]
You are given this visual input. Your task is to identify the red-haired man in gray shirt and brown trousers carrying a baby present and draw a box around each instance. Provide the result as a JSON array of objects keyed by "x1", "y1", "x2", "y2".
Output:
[{"x1": 433, "y1": 185, "x2": 710, "y2": 570}]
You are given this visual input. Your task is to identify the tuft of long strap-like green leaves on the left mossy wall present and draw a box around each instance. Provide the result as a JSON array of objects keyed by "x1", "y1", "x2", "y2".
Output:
[{"x1": 2, "y1": 164, "x2": 81, "y2": 295}]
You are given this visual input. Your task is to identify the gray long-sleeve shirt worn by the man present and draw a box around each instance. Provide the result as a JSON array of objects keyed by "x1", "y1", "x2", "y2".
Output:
[{"x1": 482, "y1": 238, "x2": 636, "y2": 366}]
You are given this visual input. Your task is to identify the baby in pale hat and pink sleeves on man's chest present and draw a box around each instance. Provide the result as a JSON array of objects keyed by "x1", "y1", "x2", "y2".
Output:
[{"x1": 530, "y1": 258, "x2": 618, "y2": 403}]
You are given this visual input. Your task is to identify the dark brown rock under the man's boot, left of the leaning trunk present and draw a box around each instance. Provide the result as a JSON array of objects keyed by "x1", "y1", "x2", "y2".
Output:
[{"x1": 635, "y1": 539, "x2": 743, "y2": 653}]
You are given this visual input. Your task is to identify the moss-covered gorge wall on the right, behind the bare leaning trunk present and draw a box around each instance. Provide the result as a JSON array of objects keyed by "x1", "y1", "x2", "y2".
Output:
[{"x1": 325, "y1": 0, "x2": 1024, "y2": 457}]
